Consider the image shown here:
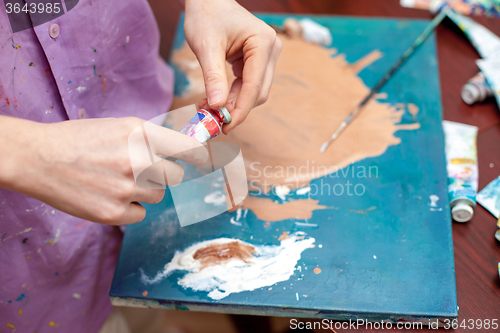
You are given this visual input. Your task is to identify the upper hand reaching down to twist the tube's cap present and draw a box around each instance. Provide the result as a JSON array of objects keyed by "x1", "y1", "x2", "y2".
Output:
[{"x1": 184, "y1": 0, "x2": 282, "y2": 134}]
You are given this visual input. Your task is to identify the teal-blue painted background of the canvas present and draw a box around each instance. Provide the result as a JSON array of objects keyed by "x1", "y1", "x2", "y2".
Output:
[{"x1": 110, "y1": 15, "x2": 457, "y2": 319}]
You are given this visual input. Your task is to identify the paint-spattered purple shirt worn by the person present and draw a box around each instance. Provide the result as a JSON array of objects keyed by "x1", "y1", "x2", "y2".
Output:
[{"x1": 0, "y1": 0, "x2": 173, "y2": 333}]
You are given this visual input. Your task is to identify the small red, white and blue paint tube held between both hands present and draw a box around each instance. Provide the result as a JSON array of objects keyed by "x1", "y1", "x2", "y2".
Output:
[{"x1": 179, "y1": 107, "x2": 231, "y2": 143}]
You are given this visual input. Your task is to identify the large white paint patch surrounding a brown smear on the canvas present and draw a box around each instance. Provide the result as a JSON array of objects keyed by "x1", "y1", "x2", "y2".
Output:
[{"x1": 140, "y1": 232, "x2": 315, "y2": 300}]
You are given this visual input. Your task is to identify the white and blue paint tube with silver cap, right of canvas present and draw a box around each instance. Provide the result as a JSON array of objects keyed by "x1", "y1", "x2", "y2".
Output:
[{"x1": 443, "y1": 121, "x2": 478, "y2": 222}]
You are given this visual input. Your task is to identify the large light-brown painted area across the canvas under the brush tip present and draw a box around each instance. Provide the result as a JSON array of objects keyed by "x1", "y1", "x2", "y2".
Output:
[{"x1": 172, "y1": 36, "x2": 420, "y2": 221}]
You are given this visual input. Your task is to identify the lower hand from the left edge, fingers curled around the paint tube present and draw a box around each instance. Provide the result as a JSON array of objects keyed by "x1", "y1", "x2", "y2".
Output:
[{"x1": 0, "y1": 118, "x2": 208, "y2": 225}]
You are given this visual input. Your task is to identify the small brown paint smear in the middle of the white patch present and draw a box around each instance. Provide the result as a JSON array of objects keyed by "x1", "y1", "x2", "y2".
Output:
[{"x1": 193, "y1": 242, "x2": 257, "y2": 269}]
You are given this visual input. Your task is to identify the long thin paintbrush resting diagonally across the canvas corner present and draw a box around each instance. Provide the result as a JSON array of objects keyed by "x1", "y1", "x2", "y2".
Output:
[{"x1": 319, "y1": 7, "x2": 450, "y2": 153}]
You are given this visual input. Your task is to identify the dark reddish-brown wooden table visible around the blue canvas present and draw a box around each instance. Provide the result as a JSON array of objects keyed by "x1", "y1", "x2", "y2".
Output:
[{"x1": 150, "y1": 0, "x2": 500, "y2": 332}]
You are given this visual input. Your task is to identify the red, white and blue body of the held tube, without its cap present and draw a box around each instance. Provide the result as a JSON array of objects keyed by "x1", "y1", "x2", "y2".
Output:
[{"x1": 179, "y1": 109, "x2": 222, "y2": 143}]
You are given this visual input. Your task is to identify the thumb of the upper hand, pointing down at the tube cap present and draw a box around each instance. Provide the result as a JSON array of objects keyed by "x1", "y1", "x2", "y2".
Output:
[{"x1": 198, "y1": 48, "x2": 229, "y2": 109}]
